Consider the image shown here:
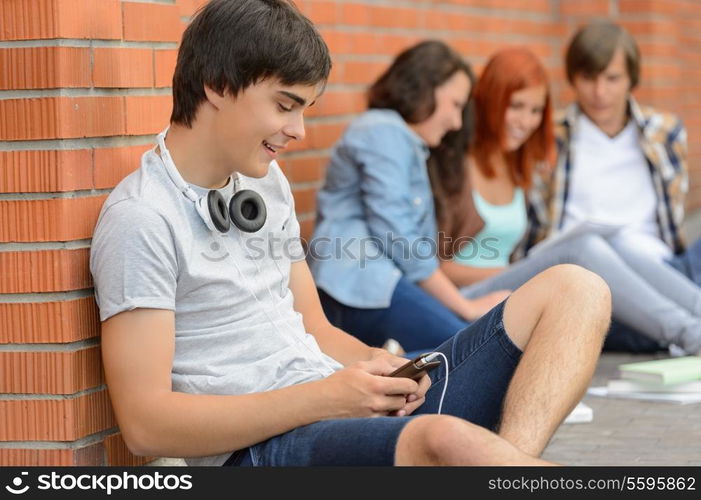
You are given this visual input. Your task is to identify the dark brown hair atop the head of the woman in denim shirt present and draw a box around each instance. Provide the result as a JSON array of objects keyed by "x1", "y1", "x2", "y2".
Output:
[{"x1": 368, "y1": 40, "x2": 475, "y2": 123}]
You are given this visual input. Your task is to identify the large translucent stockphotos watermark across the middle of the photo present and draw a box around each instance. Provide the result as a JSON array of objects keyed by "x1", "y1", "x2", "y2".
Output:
[{"x1": 200, "y1": 233, "x2": 500, "y2": 269}]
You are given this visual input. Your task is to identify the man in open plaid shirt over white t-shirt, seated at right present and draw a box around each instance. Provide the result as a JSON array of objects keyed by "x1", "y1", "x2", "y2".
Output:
[{"x1": 516, "y1": 21, "x2": 701, "y2": 351}]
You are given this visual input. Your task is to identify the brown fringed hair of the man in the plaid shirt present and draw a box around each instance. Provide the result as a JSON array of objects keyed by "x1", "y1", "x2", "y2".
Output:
[{"x1": 565, "y1": 20, "x2": 640, "y2": 89}]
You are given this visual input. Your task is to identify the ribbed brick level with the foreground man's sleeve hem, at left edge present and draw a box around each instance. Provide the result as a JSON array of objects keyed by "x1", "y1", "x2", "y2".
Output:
[{"x1": 0, "y1": 296, "x2": 100, "y2": 344}]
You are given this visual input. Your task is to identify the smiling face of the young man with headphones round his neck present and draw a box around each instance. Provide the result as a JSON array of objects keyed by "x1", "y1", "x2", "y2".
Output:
[{"x1": 205, "y1": 79, "x2": 322, "y2": 177}]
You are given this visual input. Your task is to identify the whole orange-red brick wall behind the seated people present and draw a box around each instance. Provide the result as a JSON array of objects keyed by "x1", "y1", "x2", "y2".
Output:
[{"x1": 0, "y1": 0, "x2": 701, "y2": 465}]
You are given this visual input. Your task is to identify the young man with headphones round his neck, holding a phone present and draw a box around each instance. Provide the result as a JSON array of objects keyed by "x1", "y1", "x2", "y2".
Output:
[{"x1": 90, "y1": 0, "x2": 610, "y2": 466}]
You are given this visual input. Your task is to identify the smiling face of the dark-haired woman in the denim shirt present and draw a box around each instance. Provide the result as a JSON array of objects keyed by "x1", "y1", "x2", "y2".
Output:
[{"x1": 409, "y1": 71, "x2": 470, "y2": 147}]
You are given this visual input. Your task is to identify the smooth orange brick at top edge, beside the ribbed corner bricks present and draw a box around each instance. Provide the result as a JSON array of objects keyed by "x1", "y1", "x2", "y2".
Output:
[{"x1": 122, "y1": 2, "x2": 180, "y2": 42}]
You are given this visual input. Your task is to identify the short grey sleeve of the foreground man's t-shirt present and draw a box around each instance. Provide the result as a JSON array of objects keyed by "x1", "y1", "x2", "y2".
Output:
[{"x1": 90, "y1": 200, "x2": 178, "y2": 321}]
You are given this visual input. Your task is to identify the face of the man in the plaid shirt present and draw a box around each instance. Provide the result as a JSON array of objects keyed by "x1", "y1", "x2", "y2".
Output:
[{"x1": 572, "y1": 47, "x2": 631, "y2": 136}]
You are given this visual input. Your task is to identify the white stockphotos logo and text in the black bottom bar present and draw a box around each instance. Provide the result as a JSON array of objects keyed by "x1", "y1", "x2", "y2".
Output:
[{"x1": 5, "y1": 471, "x2": 192, "y2": 495}]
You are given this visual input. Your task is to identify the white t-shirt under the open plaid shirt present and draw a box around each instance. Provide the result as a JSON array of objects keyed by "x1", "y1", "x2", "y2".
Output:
[{"x1": 563, "y1": 113, "x2": 671, "y2": 258}]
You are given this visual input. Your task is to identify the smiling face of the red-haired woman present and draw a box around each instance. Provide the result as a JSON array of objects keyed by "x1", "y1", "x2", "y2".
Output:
[{"x1": 503, "y1": 85, "x2": 548, "y2": 152}]
